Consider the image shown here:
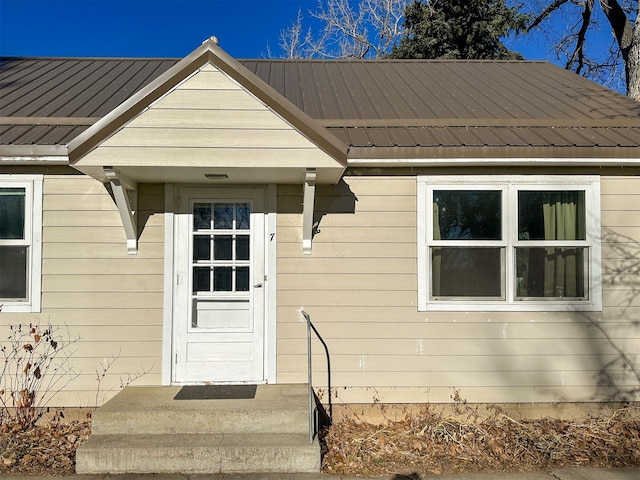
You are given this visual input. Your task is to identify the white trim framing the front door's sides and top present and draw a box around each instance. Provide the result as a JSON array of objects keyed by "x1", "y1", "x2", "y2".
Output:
[{"x1": 162, "y1": 183, "x2": 277, "y2": 385}]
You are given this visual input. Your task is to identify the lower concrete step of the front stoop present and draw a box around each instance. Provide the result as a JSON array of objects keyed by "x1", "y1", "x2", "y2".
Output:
[{"x1": 76, "y1": 434, "x2": 320, "y2": 474}]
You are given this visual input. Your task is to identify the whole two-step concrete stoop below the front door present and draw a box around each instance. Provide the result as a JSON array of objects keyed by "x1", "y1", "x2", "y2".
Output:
[{"x1": 76, "y1": 385, "x2": 320, "y2": 474}]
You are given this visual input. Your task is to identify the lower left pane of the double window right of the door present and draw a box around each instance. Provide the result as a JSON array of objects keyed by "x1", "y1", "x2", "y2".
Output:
[{"x1": 431, "y1": 247, "x2": 503, "y2": 298}]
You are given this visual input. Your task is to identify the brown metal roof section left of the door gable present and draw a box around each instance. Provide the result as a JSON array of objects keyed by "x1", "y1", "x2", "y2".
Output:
[{"x1": 0, "y1": 57, "x2": 177, "y2": 145}]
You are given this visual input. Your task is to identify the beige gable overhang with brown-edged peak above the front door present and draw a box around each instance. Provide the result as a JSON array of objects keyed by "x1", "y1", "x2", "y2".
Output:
[{"x1": 68, "y1": 38, "x2": 347, "y2": 184}]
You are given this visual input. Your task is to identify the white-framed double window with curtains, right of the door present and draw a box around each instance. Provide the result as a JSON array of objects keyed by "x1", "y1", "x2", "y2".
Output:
[{"x1": 418, "y1": 176, "x2": 601, "y2": 310}]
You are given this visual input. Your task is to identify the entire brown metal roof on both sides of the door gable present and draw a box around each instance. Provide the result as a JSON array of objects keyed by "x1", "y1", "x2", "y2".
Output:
[{"x1": 0, "y1": 54, "x2": 640, "y2": 158}]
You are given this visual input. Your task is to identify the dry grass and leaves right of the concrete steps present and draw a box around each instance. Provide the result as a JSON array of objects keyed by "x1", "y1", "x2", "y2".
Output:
[{"x1": 323, "y1": 404, "x2": 640, "y2": 476}]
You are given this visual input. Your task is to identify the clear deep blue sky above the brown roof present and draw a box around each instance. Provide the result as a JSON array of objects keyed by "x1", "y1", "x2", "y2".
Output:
[{"x1": 0, "y1": 0, "x2": 545, "y2": 60}]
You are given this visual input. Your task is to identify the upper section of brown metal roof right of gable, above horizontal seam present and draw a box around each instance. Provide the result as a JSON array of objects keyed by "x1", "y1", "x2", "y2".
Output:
[{"x1": 243, "y1": 60, "x2": 640, "y2": 123}]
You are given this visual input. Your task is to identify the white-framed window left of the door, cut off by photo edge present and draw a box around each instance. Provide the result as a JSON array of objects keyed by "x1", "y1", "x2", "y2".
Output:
[{"x1": 0, "y1": 175, "x2": 42, "y2": 312}]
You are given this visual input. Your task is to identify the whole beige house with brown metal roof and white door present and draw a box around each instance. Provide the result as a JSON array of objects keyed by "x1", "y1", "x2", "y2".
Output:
[{"x1": 0, "y1": 39, "x2": 640, "y2": 406}]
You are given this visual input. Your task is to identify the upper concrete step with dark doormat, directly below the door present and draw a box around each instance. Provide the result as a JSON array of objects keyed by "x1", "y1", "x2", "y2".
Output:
[{"x1": 91, "y1": 385, "x2": 309, "y2": 435}]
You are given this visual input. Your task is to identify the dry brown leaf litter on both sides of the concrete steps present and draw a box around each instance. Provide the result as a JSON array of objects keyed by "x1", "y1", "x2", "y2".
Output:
[{"x1": 0, "y1": 408, "x2": 640, "y2": 476}]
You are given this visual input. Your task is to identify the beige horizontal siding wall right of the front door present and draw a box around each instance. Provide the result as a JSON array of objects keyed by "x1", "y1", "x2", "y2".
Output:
[{"x1": 277, "y1": 176, "x2": 640, "y2": 403}]
